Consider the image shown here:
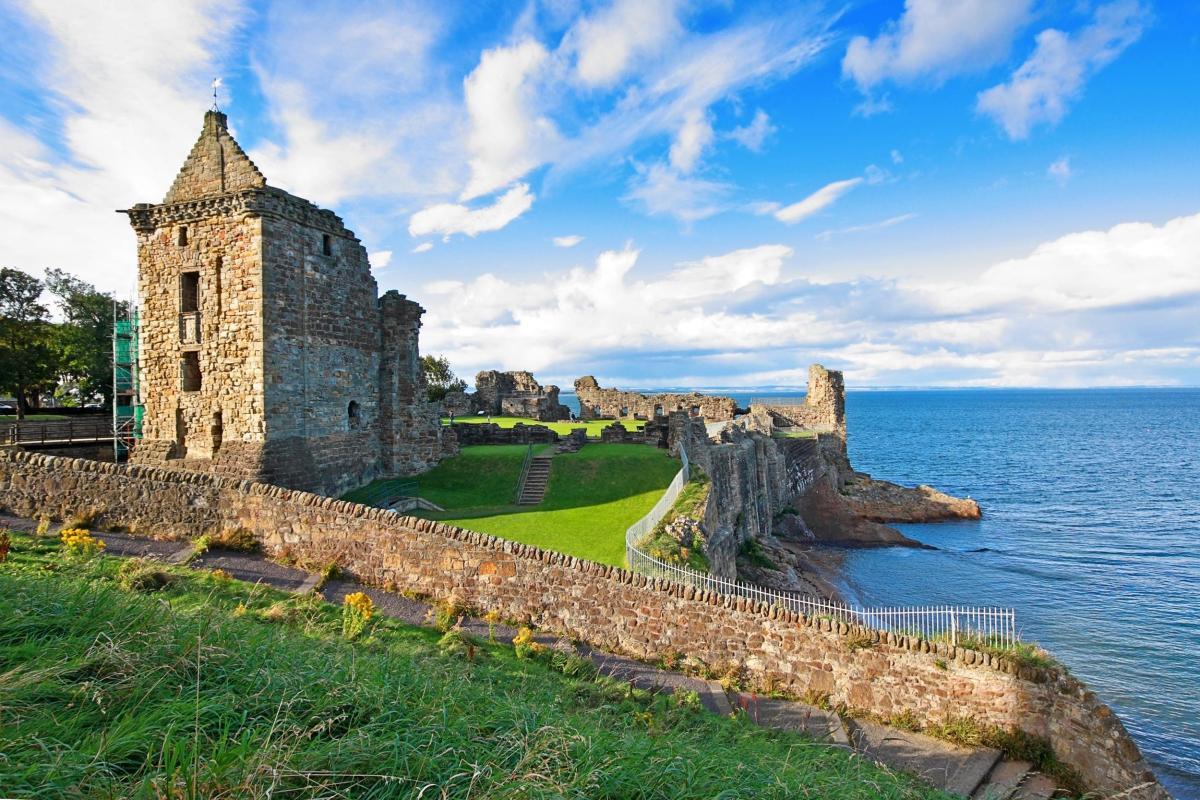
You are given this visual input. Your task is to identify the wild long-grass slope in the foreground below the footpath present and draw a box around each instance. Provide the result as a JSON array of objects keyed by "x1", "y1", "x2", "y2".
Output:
[{"x1": 0, "y1": 534, "x2": 946, "y2": 800}]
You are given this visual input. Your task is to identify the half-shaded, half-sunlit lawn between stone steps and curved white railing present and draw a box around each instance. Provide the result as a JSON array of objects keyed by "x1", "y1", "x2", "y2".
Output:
[{"x1": 421, "y1": 445, "x2": 679, "y2": 566}]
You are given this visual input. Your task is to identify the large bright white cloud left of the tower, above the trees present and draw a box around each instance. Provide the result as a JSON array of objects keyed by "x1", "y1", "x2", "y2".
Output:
[{"x1": 0, "y1": 1, "x2": 242, "y2": 296}]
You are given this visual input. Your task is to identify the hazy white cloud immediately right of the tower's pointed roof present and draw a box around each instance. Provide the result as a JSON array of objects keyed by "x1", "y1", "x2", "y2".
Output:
[{"x1": 248, "y1": 0, "x2": 463, "y2": 205}]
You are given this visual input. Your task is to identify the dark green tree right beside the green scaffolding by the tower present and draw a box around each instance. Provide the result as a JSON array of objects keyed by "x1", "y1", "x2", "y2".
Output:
[{"x1": 46, "y1": 270, "x2": 127, "y2": 404}]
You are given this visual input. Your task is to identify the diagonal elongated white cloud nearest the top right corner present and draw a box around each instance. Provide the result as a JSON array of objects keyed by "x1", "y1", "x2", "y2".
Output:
[{"x1": 976, "y1": 0, "x2": 1148, "y2": 139}]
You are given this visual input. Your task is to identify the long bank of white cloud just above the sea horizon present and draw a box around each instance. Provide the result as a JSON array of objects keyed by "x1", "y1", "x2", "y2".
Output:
[{"x1": 422, "y1": 213, "x2": 1200, "y2": 386}]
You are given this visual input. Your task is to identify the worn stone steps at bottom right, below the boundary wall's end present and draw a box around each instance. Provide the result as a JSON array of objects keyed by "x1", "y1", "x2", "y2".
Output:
[{"x1": 846, "y1": 720, "x2": 1055, "y2": 800}]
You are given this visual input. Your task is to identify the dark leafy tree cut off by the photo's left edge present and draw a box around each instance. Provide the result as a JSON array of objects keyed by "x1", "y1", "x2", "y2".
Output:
[{"x1": 0, "y1": 266, "x2": 59, "y2": 420}]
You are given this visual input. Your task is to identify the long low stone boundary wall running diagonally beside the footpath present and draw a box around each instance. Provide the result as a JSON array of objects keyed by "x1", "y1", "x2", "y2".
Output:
[{"x1": 0, "y1": 452, "x2": 1168, "y2": 799}]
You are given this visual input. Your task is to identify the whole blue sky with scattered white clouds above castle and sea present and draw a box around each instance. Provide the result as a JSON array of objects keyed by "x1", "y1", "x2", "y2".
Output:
[{"x1": 0, "y1": 0, "x2": 1200, "y2": 386}]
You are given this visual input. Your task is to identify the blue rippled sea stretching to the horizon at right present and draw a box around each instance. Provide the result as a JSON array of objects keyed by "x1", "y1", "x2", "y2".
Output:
[{"x1": 561, "y1": 389, "x2": 1200, "y2": 800}]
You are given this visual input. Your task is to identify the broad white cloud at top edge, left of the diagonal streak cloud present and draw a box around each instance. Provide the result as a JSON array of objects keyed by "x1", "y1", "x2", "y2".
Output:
[{"x1": 841, "y1": 0, "x2": 1032, "y2": 92}]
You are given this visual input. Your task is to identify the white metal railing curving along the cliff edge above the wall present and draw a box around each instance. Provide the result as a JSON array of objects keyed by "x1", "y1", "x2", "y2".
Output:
[{"x1": 625, "y1": 446, "x2": 1020, "y2": 648}]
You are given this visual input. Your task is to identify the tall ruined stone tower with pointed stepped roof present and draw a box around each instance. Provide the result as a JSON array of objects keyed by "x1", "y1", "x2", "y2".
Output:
[{"x1": 127, "y1": 110, "x2": 454, "y2": 494}]
